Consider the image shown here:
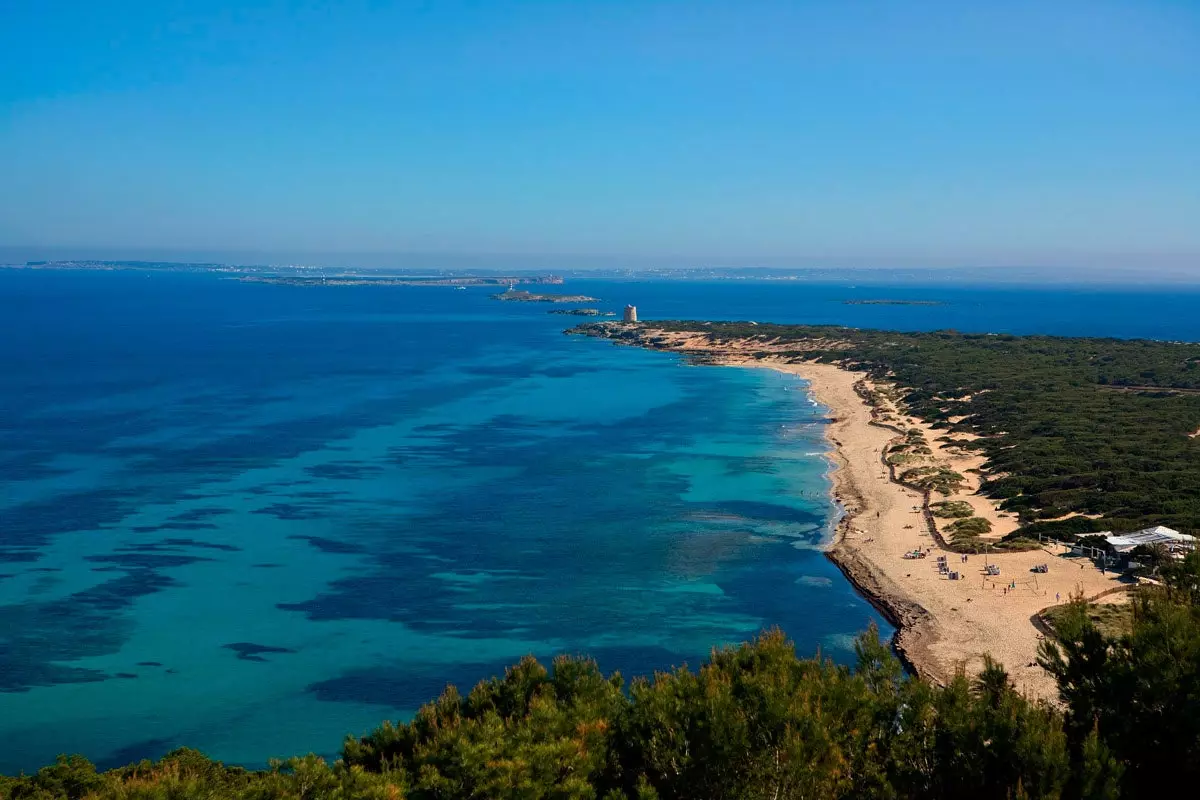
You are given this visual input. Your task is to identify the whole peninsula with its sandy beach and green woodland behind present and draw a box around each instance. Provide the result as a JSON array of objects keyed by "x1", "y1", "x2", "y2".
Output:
[{"x1": 570, "y1": 321, "x2": 1200, "y2": 698}]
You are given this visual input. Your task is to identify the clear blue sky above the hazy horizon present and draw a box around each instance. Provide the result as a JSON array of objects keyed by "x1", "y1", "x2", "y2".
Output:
[{"x1": 0, "y1": 0, "x2": 1200, "y2": 269}]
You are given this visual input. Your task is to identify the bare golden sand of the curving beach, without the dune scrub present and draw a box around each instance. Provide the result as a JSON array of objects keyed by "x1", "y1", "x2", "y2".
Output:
[{"x1": 604, "y1": 335, "x2": 1123, "y2": 700}]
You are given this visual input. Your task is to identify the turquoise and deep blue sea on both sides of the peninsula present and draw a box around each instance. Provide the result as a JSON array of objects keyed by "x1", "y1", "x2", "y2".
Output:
[{"x1": 0, "y1": 270, "x2": 1200, "y2": 772}]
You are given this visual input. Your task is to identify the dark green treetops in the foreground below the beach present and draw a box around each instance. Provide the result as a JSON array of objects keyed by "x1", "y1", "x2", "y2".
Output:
[{"x1": 0, "y1": 554, "x2": 1200, "y2": 800}]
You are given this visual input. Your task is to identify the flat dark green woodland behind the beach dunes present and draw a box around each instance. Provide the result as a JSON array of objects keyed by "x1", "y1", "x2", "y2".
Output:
[{"x1": 585, "y1": 321, "x2": 1200, "y2": 539}]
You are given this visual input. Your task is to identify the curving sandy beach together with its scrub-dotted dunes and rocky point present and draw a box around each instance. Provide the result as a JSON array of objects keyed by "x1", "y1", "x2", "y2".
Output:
[{"x1": 572, "y1": 323, "x2": 1180, "y2": 699}]
